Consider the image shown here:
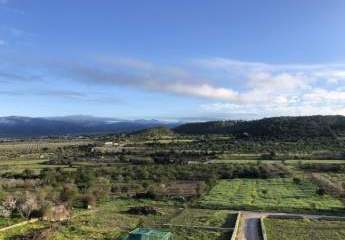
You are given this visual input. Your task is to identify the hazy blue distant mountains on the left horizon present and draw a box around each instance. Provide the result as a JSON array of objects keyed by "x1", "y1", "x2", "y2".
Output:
[{"x1": 0, "y1": 115, "x2": 177, "y2": 137}]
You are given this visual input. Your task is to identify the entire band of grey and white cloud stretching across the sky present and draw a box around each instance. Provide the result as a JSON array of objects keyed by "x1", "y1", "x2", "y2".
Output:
[{"x1": 0, "y1": 57, "x2": 345, "y2": 117}]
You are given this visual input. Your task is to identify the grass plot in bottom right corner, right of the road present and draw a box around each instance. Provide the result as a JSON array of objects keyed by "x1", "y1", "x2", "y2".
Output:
[{"x1": 264, "y1": 218, "x2": 345, "y2": 240}]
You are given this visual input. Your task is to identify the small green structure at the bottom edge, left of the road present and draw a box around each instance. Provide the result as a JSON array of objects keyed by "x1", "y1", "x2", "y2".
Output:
[{"x1": 125, "y1": 228, "x2": 172, "y2": 240}]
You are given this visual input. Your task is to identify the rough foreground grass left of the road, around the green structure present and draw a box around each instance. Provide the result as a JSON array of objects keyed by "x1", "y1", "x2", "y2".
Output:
[{"x1": 0, "y1": 199, "x2": 236, "y2": 240}]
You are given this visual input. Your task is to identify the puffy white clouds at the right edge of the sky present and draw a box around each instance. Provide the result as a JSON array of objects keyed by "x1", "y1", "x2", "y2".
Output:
[{"x1": 196, "y1": 58, "x2": 345, "y2": 116}]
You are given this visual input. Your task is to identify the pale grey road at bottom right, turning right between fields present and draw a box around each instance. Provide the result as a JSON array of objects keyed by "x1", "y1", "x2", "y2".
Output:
[{"x1": 237, "y1": 212, "x2": 344, "y2": 240}]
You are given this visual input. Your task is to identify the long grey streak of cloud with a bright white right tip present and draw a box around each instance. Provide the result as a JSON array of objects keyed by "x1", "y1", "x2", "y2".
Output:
[{"x1": 66, "y1": 61, "x2": 239, "y2": 101}]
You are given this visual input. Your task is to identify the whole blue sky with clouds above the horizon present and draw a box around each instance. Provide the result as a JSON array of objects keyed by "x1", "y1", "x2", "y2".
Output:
[{"x1": 0, "y1": 0, "x2": 345, "y2": 120}]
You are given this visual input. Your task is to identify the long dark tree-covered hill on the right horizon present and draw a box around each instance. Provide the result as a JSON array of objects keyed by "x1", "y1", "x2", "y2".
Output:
[{"x1": 174, "y1": 115, "x2": 345, "y2": 139}]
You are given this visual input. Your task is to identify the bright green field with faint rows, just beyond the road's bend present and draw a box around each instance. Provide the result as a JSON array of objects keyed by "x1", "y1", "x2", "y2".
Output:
[{"x1": 199, "y1": 178, "x2": 344, "y2": 212}]
